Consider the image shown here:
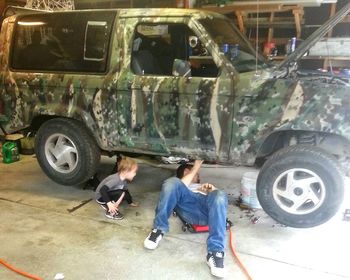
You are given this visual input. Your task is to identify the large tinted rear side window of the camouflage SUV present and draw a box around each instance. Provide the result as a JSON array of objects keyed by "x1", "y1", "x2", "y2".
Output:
[{"x1": 11, "y1": 12, "x2": 115, "y2": 73}]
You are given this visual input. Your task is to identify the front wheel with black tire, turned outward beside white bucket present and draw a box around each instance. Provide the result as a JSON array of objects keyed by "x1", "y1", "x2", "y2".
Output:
[{"x1": 257, "y1": 145, "x2": 344, "y2": 228}]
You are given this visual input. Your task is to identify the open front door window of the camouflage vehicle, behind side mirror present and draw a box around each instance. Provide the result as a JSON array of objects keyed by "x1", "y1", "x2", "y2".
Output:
[{"x1": 131, "y1": 23, "x2": 218, "y2": 77}]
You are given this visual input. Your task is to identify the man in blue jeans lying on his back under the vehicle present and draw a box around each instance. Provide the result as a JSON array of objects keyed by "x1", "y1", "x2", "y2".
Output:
[{"x1": 144, "y1": 160, "x2": 228, "y2": 278}]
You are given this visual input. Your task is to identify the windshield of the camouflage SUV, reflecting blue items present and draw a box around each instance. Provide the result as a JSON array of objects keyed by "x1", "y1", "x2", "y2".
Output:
[{"x1": 199, "y1": 18, "x2": 267, "y2": 73}]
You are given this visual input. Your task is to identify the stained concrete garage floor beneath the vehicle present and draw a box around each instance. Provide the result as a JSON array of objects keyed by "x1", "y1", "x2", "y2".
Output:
[{"x1": 0, "y1": 156, "x2": 350, "y2": 280}]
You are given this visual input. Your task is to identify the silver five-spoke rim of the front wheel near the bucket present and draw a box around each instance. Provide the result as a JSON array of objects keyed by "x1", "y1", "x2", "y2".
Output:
[{"x1": 272, "y1": 168, "x2": 326, "y2": 215}]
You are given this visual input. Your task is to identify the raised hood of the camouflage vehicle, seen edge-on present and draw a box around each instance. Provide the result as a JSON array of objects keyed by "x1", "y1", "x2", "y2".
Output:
[{"x1": 277, "y1": 2, "x2": 350, "y2": 69}]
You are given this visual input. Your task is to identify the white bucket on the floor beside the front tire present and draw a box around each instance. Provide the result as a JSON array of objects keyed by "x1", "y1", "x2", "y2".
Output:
[{"x1": 241, "y1": 171, "x2": 261, "y2": 209}]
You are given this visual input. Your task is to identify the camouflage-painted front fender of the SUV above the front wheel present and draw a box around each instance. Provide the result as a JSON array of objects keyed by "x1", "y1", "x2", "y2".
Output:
[{"x1": 231, "y1": 74, "x2": 350, "y2": 164}]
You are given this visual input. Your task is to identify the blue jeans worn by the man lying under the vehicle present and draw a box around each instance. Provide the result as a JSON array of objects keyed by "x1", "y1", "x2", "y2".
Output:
[{"x1": 153, "y1": 177, "x2": 227, "y2": 252}]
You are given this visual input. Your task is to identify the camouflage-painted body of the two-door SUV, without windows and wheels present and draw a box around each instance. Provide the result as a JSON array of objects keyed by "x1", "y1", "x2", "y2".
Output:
[{"x1": 0, "y1": 9, "x2": 350, "y2": 165}]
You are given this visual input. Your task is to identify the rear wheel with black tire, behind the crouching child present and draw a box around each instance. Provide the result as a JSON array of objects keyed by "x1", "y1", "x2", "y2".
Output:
[{"x1": 35, "y1": 118, "x2": 101, "y2": 185}]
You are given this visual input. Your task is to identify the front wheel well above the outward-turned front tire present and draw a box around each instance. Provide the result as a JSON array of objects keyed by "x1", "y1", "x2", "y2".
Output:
[{"x1": 257, "y1": 130, "x2": 350, "y2": 161}]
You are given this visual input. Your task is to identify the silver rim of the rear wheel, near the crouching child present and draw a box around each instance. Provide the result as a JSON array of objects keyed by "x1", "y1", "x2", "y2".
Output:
[{"x1": 45, "y1": 133, "x2": 79, "y2": 173}]
